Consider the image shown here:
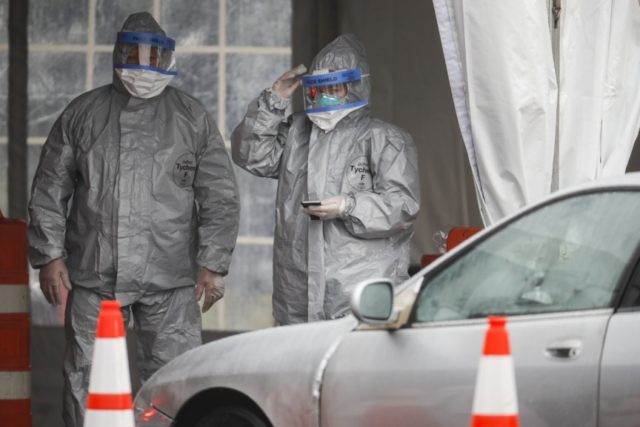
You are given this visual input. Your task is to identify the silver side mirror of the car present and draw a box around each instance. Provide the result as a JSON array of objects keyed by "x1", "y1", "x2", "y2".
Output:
[{"x1": 351, "y1": 279, "x2": 396, "y2": 324}]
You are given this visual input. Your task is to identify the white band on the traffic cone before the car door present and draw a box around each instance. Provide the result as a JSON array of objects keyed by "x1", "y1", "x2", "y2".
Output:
[{"x1": 473, "y1": 356, "x2": 518, "y2": 415}]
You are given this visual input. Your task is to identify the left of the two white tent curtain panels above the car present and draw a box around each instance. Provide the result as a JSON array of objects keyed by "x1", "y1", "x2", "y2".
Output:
[{"x1": 434, "y1": 0, "x2": 557, "y2": 224}]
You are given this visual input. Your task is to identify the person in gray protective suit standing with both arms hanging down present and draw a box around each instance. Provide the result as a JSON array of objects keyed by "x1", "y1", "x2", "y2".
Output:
[{"x1": 28, "y1": 13, "x2": 240, "y2": 426}]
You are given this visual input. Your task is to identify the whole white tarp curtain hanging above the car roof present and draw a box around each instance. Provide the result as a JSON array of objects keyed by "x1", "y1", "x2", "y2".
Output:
[{"x1": 433, "y1": 0, "x2": 640, "y2": 224}]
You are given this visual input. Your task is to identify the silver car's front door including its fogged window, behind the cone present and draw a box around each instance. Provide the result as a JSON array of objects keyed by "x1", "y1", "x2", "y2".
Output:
[{"x1": 320, "y1": 191, "x2": 640, "y2": 427}]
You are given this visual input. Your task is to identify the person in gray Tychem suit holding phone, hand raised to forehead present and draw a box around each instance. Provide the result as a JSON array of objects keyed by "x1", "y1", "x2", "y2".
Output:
[{"x1": 231, "y1": 34, "x2": 420, "y2": 325}]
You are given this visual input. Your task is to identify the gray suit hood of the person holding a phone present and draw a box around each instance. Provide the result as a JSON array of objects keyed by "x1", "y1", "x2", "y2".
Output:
[{"x1": 310, "y1": 34, "x2": 371, "y2": 104}]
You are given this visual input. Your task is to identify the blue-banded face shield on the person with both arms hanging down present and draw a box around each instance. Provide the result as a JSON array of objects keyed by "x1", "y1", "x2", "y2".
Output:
[{"x1": 113, "y1": 31, "x2": 177, "y2": 75}]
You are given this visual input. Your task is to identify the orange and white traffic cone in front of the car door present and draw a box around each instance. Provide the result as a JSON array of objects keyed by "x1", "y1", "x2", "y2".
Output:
[{"x1": 471, "y1": 317, "x2": 519, "y2": 427}]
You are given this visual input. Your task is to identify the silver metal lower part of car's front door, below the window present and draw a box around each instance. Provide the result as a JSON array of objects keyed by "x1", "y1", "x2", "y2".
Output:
[{"x1": 320, "y1": 309, "x2": 611, "y2": 427}]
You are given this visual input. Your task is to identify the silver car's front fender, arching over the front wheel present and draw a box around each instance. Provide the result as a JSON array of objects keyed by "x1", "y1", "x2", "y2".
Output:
[{"x1": 136, "y1": 315, "x2": 358, "y2": 425}]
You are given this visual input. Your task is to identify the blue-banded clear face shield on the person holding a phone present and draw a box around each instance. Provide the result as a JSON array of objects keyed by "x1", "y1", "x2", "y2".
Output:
[{"x1": 302, "y1": 68, "x2": 367, "y2": 113}]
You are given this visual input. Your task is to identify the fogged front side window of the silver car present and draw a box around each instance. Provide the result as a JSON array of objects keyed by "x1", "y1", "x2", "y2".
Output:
[{"x1": 414, "y1": 191, "x2": 640, "y2": 322}]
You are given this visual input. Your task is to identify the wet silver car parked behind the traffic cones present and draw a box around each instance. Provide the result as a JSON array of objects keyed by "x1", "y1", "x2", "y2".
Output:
[{"x1": 135, "y1": 174, "x2": 640, "y2": 427}]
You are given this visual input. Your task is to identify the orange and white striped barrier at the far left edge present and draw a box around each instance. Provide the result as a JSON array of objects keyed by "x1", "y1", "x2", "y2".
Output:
[{"x1": 0, "y1": 212, "x2": 31, "y2": 427}]
